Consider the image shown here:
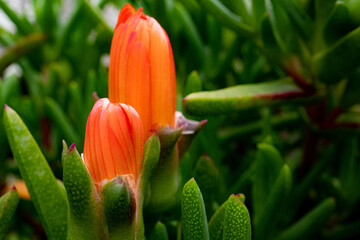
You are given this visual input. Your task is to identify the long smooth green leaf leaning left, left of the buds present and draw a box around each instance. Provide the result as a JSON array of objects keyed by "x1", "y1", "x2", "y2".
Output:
[{"x1": 4, "y1": 106, "x2": 68, "y2": 239}]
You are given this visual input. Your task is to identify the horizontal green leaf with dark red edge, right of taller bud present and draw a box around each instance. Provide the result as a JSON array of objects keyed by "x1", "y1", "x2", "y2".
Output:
[{"x1": 183, "y1": 78, "x2": 311, "y2": 116}]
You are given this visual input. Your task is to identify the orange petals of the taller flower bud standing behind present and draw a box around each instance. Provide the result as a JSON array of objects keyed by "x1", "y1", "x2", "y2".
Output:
[{"x1": 109, "y1": 4, "x2": 176, "y2": 134}]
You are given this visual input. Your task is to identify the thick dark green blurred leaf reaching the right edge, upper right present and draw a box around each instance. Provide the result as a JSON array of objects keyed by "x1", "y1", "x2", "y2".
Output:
[{"x1": 312, "y1": 27, "x2": 360, "y2": 84}]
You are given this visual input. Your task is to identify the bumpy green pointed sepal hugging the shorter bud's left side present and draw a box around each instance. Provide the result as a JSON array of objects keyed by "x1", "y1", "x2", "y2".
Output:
[{"x1": 63, "y1": 144, "x2": 105, "y2": 240}]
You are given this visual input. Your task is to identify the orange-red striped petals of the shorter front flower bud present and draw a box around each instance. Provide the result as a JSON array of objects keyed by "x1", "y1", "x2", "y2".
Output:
[{"x1": 83, "y1": 98, "x2": 145, "y2": 183}]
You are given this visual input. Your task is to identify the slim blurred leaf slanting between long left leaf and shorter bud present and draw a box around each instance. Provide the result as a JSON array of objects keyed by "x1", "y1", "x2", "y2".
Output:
[{"x1": 45, "y1": 98, "x2": 82, "y2": 145}]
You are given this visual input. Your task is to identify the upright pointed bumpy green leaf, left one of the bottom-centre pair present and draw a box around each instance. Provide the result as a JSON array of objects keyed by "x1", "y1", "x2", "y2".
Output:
[{"x1": 181, "y1": 178, "x2": 209, "y2": 240}]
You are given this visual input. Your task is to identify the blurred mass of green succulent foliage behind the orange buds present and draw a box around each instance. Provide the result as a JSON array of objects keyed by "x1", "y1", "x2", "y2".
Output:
[{"x1": 0, "y1": 0, "x2": 360, "y2": 240}]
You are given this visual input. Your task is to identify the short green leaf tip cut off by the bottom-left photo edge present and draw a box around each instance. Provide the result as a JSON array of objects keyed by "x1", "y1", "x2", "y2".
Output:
[{"x1": 0, "y1": 187, "x2": 19, "y2": 239}]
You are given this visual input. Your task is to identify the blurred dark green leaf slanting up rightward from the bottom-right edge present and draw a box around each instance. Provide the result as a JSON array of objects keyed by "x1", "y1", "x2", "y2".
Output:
[{"x1": 276, "y1": 198, "x2": 335, "y2": 240}]
